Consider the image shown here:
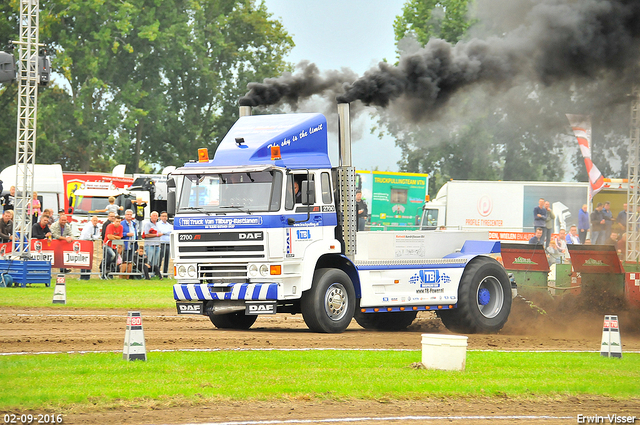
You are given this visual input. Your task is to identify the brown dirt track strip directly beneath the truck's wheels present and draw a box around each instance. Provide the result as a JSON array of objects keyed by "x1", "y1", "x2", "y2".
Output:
[{"x1": 0, "y1": 294, "x2": 640, "y2": 353}]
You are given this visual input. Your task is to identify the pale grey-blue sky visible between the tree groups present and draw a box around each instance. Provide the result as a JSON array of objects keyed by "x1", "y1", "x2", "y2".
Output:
[{"x1": 264, "y1": 0, "x2": 406, "y2": 171}]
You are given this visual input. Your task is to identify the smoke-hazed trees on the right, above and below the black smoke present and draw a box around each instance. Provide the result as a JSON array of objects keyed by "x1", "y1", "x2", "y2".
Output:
[{"x1": 380, "y1": 0, "x2": 629, "y2": 194}]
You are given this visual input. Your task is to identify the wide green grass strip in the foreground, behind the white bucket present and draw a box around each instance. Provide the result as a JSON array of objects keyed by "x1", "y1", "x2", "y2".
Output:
[{"x1": 0, "y1": 351, "x2": 640, "y2": 411}]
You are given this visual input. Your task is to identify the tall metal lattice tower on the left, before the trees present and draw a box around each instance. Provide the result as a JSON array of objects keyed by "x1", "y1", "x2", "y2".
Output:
[{"x1": 13, "y1": 0, "x2": 40, "y2": 255}]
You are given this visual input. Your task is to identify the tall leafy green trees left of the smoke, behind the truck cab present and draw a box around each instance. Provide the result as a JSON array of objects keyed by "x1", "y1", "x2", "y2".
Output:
[{"x1": 0, "y1": 0, "x2": 293, "y2": 172}]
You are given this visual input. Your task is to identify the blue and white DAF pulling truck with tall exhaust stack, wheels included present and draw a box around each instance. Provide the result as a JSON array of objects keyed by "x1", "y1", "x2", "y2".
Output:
[{"x1": 168, "y1": 104, "x2": 515, "y2": 333}]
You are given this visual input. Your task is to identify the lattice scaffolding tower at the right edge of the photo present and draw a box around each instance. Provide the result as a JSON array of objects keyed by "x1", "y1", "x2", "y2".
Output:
[{"x1": 625, "y1": 85, "x2": 640, "y2": 263}]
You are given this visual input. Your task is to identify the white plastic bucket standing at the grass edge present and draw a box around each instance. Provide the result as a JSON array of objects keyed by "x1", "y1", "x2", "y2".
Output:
[{"x1": 422, "y1": 334, "x2": 467, "y2": 370}]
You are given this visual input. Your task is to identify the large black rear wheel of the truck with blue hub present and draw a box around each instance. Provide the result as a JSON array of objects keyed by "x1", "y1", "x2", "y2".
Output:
[{"x1": 438, "y1": 257, "x2": 511, "y2": 333}]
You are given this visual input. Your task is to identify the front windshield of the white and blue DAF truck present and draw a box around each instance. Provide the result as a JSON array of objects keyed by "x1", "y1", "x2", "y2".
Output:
[{"x1": 178, "y1": 170, "x2": 282, "y2": 213}]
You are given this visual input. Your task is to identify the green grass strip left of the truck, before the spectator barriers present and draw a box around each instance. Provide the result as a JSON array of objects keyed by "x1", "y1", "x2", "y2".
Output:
[{"x1": 0, "y1": 278, "x2": 176, "y2": 310}]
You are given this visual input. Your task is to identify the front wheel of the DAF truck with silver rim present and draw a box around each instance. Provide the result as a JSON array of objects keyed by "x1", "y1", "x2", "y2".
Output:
[{"x1": 300, "y1": 269, "x2": 356, "y2": 333}]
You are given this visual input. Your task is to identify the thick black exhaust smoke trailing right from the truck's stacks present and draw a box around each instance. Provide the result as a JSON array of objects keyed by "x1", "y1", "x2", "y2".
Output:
[{"x1": 240, "y1": 0, "x2": 640, "y2": 121}]
